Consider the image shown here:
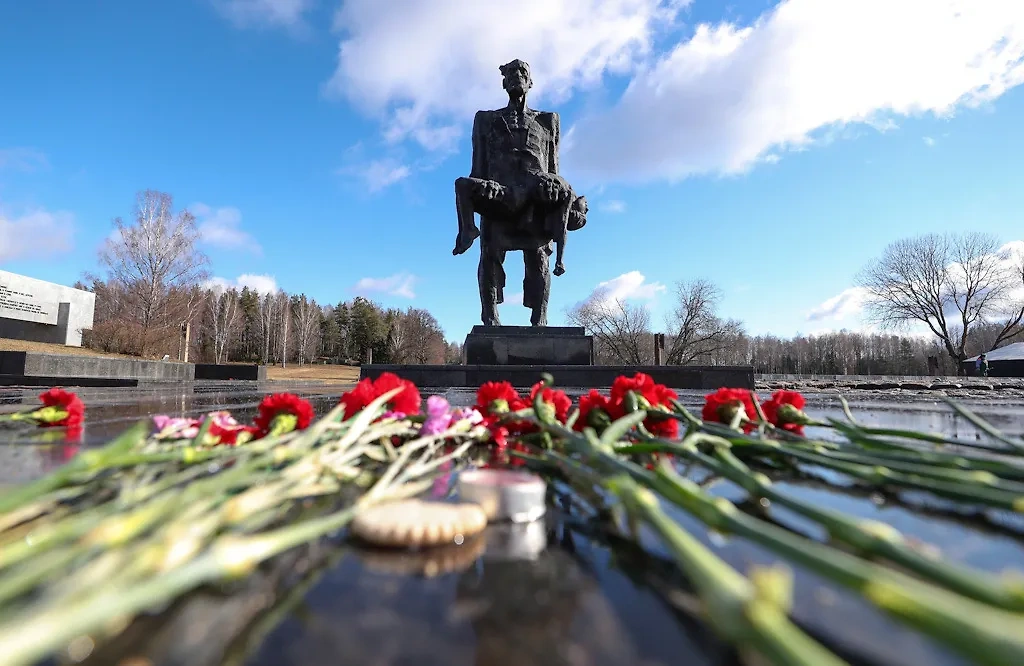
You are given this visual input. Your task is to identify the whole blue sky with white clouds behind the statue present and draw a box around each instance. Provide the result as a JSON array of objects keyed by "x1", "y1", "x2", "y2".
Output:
[{"x1": 0, "y1": 0, "x2": 1024, "y2": 340}]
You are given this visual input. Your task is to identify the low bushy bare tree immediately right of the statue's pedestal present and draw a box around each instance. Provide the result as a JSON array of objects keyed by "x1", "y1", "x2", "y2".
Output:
[{"x1": 565, "y1": 296, "x2": 654, "y2": 366}]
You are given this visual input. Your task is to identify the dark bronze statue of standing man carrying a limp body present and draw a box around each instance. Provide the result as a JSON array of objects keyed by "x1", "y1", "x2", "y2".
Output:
[{"x1": 452, "y1": 59, "x2": 587, "y2": 326}]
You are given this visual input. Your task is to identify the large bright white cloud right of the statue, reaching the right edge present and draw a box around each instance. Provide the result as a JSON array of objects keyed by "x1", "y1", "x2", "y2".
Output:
[{"x1": 565, "y1": 0, "x2": 1024, "y2": 180}]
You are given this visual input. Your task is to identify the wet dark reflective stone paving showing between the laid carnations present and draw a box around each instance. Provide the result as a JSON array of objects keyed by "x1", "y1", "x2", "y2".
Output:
[{"x1": 6, "y1": 382, "x2": 1024, "y2": 666}]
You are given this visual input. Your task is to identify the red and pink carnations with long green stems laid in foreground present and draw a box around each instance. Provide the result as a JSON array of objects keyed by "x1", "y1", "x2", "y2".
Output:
[{"x1": 0, "y1": 373, "x2": 1024, "y2": 666}]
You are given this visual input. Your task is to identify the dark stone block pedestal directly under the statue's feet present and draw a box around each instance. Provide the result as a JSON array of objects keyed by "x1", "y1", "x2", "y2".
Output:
[{"x1": 462, "y1": 326, "x2": 594, "y2": 366}]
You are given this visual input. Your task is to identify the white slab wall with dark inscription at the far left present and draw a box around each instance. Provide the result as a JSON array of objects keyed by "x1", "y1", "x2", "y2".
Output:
[{"x1": 0, "y1": 270, "x2": 96, "y2": 347}]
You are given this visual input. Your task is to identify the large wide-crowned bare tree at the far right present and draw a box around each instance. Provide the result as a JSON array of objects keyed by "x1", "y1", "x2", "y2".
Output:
[{"x1": 857, "y1": 233, "x2": 1024, "y2": 366}]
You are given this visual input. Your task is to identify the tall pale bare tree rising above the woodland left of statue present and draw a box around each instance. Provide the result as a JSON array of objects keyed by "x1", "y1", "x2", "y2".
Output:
[{"x1": 99, "y1": 190, "x2": 208, "y2": 355}]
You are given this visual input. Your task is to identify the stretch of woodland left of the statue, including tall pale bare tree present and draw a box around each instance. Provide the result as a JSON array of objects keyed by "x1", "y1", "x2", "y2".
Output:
[{"x1": 76, "y1": 191, "x2": 461, "y2": 365}]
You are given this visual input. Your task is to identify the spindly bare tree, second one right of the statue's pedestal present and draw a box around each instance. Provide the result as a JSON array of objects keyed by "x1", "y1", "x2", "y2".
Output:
[{"x1": 666, "y1": 280, "x2": 743, "y2": 366}]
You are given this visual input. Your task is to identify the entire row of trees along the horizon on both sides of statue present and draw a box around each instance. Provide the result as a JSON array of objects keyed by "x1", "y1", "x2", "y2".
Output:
[{"x1": 77, "y1": 191, "x2": 1024, "y2": 375}]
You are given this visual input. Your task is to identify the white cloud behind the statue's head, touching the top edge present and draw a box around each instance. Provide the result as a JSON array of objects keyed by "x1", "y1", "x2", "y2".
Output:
[{"x1": 327, "y1": 0, "x2": 688, "y2": 150}]
